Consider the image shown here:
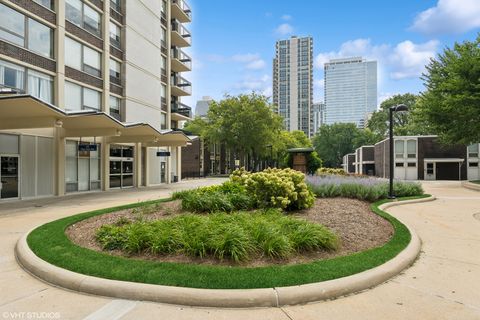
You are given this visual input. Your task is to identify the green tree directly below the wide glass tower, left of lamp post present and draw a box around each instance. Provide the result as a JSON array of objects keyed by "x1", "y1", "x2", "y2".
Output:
[{"x1": 313, "y1": 123, "x2": 377, "y2": 168}]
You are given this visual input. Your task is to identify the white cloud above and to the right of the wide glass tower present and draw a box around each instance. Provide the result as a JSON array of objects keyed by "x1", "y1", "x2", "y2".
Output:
[{"x1": 315, "y1": 39, "x2": 439, "y2": 82}]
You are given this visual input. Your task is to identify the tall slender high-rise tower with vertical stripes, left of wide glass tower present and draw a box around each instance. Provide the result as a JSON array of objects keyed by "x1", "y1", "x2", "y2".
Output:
[{"x1": 273, "y1": 37, "x2": 313, "y2": 137}]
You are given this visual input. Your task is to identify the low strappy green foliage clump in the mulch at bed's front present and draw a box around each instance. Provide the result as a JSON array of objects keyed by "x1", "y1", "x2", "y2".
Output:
[{"x1": 96, "y1": 209, "x2": 338, "y2": 262}]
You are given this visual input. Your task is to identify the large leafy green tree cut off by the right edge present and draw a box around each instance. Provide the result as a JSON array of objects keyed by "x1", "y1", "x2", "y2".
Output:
[{"x1": 416, "y1": 34, "x2": 480, "y2": 144}]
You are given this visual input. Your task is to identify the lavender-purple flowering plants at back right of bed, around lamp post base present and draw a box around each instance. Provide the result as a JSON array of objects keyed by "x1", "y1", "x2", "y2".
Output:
[{"x1": 307, "y1": 175, "x2": 423, "y2": 201}]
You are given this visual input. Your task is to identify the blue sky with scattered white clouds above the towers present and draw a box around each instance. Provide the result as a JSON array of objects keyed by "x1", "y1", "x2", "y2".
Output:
[{"x1": 184, "y1": 0, "x2": 480, "y2": 107}]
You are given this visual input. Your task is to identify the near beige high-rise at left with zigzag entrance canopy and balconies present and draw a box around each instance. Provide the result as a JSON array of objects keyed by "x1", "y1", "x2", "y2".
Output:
[{"x1": 0, "y1": 0, "x2": 191, "y2": 200}]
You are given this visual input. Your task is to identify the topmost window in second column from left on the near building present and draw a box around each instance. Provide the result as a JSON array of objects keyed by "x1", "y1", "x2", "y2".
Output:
[{"x1": 65, "y1": 0, "x2": 102, "y2": 35}]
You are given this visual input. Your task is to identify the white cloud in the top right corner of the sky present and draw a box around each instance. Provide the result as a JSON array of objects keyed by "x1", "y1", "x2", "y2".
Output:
[{"x1": 410, "y1": 0, "x2": 480, "y2": 34}]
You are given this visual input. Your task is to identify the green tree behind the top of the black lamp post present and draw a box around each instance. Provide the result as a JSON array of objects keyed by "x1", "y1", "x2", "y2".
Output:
[{"x1": 367, "y1": 93, "x2": 426, "y2": 141}]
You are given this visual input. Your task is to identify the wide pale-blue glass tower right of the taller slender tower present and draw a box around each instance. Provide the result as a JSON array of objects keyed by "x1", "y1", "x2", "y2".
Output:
[{"x1": 324, "y1": 57, "x2": 377, "y2": 128}]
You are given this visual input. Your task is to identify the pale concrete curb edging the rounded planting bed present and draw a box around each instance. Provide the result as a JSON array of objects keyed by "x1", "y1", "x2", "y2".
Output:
[{"x1": 15, "y1": 197, "x2": 435, "y2": 308}]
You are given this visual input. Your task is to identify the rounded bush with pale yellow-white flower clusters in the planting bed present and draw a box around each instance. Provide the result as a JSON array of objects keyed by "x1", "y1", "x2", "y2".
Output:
[{"x1": 230, "y1": 168, "x2": 315, "y2": 210}]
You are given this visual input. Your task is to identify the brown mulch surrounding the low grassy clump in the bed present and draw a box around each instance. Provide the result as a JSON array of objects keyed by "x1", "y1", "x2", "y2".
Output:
[{"x1": 66, "y1": 198, "x2": 393, "y2": 267}]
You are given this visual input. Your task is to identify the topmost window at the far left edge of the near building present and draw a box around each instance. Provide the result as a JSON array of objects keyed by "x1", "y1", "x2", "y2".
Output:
[{"x1": 0, "y1": 4, "x2": 53, "y2": 58}]
